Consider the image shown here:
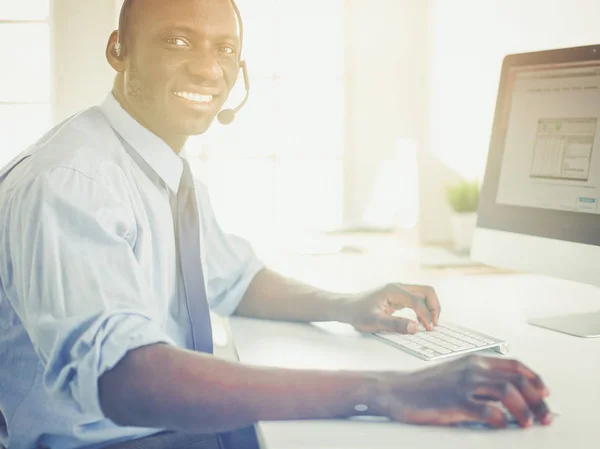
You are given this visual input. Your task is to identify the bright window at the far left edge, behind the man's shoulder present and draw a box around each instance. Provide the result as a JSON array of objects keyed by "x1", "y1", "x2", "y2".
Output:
[{"x1": 0, "y1": 0, "x2": 51, "y2": 166}]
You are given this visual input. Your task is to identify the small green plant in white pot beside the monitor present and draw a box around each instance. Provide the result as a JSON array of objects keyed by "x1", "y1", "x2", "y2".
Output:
[{"x1": 447, "y1": 181, "x2": 479, "y2": 253}]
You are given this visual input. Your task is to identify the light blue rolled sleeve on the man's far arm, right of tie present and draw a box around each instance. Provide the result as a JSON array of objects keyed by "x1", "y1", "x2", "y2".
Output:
[{"x1": 196, "y1": 184, "x2": 264, "y2": 316}]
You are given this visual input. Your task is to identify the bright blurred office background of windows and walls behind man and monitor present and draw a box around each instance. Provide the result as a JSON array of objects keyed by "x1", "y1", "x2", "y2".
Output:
[{"x1": 0, "y1": 0, "x2": 600, "y2": 264}]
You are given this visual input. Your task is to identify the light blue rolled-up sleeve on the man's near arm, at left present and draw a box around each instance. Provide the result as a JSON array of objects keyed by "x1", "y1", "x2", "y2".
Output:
[{"x1": 0, "y1": 168, "x2": 174, "y2": 417}]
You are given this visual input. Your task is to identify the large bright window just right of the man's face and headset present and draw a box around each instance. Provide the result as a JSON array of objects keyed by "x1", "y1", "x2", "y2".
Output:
[{"x1": 188, "y1": 0, "x2": 345, "y2": 247}]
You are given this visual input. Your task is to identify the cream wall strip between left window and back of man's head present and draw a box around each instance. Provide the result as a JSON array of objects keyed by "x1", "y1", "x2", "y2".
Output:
[{"x1": 50, "y1": 0, "x2": 117, "y2": 122}]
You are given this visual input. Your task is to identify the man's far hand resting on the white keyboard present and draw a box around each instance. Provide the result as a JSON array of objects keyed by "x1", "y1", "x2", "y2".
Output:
[{"x1": 340, "y1": 284, "x2": 441, "y2": 334}]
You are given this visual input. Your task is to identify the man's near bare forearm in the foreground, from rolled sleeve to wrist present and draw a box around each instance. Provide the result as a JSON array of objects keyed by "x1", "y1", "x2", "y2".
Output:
[{"x1": 100, "y1": 344, "x2": 380, "y2": 433}]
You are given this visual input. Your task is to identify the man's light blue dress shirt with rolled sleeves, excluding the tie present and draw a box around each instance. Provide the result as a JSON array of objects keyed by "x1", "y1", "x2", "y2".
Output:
[{"x1": 0, "y1": 94, "x2": 263, "y2": 449}]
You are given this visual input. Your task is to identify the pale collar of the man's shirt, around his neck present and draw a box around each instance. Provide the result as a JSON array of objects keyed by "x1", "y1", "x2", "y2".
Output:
[{"x1": 100, "y1": 92, "x2": 183, "y2": 194}]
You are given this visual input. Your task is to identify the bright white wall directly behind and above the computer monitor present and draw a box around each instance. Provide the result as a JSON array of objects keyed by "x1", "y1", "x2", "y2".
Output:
[{"x1": 431, "y1": 0, "x2": 600, "y2": 176}]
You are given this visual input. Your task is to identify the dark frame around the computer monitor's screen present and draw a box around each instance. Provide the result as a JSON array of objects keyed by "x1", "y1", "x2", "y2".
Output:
[{"x1": 477, "y1": 44, "x2": 600, "y2": 246}]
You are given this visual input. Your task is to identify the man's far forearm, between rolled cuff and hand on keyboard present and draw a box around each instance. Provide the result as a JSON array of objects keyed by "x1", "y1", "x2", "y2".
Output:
[{"x1": 235, "y1": 269, "x2": 350, "y2": 322}]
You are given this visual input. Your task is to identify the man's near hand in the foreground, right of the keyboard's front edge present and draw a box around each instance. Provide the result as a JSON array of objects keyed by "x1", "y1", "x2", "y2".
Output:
[{"x1": 375, "y1": 355, "x2": 552, "y2": 428}]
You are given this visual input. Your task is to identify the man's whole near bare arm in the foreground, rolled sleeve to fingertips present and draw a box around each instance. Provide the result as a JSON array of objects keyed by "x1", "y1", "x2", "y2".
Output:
[{"x1": 99, "y1": 344, "x2": 551, "y2": 433}]
